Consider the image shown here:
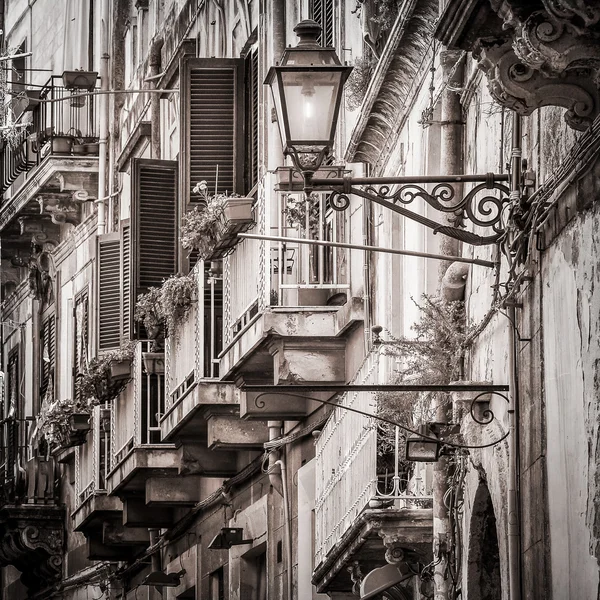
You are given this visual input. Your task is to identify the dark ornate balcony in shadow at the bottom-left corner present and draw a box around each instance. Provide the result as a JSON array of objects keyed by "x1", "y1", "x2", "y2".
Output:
[{"x1": 0, "y1": 420, "x2": 65, "y2": 596}]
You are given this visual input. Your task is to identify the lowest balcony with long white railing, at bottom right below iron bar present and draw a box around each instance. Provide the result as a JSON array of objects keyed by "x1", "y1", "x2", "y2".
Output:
[{"x1": 313, "y1": 353, "x2": 433, "y2": 593}]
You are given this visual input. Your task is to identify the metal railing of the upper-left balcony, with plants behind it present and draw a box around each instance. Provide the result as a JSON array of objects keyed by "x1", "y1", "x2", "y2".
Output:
[{"x1": 0, "y1": 76, "x2": 99, "y2": 194}]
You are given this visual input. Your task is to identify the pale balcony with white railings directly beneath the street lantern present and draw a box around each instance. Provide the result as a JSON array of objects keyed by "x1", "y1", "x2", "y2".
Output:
[{"x1": 219, "y1": 170, "x2": 362, "y2": 404}]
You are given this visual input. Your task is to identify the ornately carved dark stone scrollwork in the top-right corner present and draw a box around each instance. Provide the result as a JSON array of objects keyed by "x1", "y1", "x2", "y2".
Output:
[{"x1": 435, "y1": 0, "x2": 600, "y2": 130}]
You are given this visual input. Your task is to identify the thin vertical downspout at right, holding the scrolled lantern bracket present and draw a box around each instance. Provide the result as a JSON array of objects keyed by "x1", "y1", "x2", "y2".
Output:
[{"x1": 507, "y1": 112, "x2": 522, "y2": 600}]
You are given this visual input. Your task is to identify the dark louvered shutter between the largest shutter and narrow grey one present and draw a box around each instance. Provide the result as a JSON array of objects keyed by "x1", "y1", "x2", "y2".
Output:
[{"x1": 131, "y1": 158, "x2": 178, "y2": 298}]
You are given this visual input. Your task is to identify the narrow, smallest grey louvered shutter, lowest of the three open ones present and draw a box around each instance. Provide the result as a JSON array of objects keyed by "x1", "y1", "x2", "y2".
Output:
[{"x1": 98, "y1": 233, "x2": 121, "y2": 350}]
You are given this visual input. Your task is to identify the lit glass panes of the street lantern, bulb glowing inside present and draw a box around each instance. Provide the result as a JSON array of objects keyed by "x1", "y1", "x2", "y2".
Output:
[{"x1": 281, "y1": 70, "x2": 342, "y2": 144}]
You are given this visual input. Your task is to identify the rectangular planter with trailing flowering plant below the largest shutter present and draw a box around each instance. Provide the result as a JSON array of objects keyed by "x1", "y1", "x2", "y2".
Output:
[{"x1": 181, "y1": 181, "x2": 254, "y2": 260}]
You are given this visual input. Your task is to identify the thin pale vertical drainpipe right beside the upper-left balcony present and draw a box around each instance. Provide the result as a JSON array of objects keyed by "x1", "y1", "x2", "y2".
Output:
[{"x1": 96, "y1": 0, "x2": 110, "y2": 235}]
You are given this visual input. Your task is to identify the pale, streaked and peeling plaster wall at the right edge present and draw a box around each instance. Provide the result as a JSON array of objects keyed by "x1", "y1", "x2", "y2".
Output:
[{"x1": 543, "y1": 199, "x2": 600, "y2": 599}]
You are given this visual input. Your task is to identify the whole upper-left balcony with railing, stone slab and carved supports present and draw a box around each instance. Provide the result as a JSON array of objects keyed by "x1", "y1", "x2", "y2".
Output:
[{"x1": 0, "y1": 76, "x2": 99, "y2": 230}]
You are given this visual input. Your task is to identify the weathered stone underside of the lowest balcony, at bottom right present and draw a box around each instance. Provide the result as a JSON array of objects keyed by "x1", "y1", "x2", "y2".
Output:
[{"x1": 313, "y1": 508, "x2": 433, "y2": 593}]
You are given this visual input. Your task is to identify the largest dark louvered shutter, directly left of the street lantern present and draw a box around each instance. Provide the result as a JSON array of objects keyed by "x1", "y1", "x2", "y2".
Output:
[{"x1": 180, "y1": 58, "x2": 245, "y2": 204}]
